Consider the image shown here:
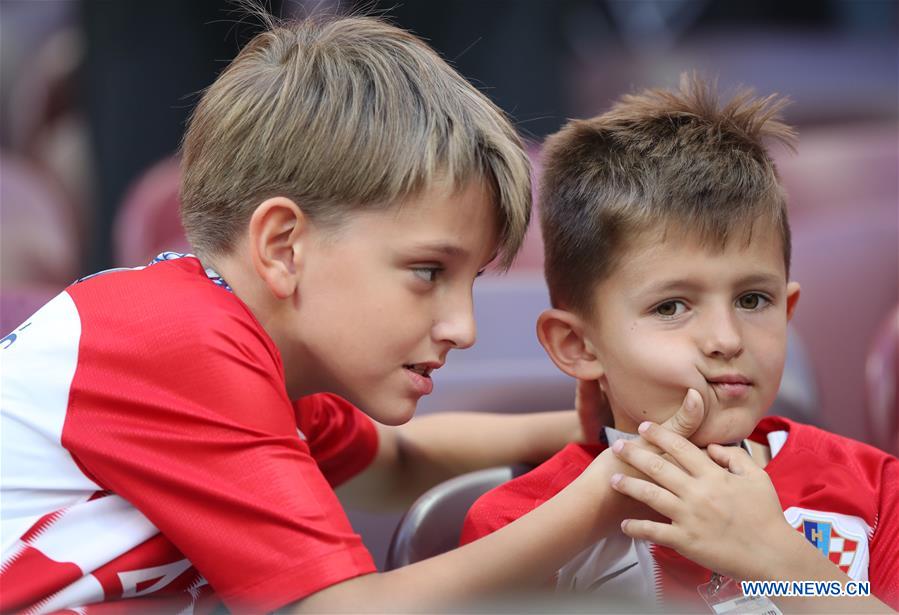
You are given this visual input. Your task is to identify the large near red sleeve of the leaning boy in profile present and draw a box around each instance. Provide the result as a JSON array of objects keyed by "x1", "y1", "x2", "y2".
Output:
[{"x1": 63, "y1": 263, "x2": 375, "y2": 612}]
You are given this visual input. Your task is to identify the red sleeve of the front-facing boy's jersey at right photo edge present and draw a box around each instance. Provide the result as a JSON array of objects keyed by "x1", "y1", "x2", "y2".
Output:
[{"x1": 868, "y1": 457, "x2": 899, "y2": 610}]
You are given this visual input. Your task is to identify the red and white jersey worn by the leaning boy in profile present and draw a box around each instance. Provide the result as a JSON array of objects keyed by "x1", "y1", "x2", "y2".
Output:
[{"x1": 0, "y1": 254, "x2": 378, "y2": 613}]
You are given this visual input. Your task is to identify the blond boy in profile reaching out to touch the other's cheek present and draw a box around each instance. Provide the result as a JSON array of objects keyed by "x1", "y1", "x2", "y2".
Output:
[{"x1": 0, "y1": 17, "x2": 695, "y2": 613}]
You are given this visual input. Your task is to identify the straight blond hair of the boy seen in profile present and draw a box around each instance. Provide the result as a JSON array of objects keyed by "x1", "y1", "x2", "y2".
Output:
[{"x1": 181, "y1": 16, "x2": 531, "y2": 267}]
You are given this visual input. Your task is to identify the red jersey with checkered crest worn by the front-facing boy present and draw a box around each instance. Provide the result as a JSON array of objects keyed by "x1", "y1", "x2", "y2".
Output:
[{"x1": 462, "y1": 417, "x2": 899, "y2": 612}]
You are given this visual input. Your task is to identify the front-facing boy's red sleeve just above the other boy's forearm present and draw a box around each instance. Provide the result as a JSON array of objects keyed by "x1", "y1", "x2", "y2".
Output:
[{"x1": 459, "y1": 444, "x2": 599, "y2": 545}]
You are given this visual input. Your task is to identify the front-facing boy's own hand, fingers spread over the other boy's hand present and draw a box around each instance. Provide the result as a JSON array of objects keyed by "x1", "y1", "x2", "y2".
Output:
[{"x1": 612, "y1": 422, "x2": 804, "y2": 579}]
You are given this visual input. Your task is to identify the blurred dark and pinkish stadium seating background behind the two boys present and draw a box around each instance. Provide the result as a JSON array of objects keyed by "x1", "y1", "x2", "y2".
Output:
[{"x1": 0, "y1": 0, "x2": 899, "y2": 558}]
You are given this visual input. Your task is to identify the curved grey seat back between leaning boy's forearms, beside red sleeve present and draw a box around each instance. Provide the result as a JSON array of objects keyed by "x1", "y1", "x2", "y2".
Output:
[{"x1": 386, "y1": 465, "x2": 530, "y2": 570}]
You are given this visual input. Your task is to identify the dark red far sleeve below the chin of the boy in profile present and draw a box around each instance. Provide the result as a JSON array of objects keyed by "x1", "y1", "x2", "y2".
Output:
[{"x1": 294, "y1": 394, "x2": 378, "y2": 487}]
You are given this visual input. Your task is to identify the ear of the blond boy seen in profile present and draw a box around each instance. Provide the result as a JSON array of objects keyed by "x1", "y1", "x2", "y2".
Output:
[{"x1": 249, "y1": 196, "x2": 308, "y2": 299}]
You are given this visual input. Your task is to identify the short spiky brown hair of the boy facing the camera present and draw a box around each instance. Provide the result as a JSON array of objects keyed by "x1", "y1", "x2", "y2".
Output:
[{"x1": 540, "y1": 74, "x2": 796, "y2": 314}]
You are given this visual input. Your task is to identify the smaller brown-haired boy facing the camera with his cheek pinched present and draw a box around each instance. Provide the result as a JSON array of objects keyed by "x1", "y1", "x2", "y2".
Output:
[{"x1": 463, "y1": 77, "x2": 899, "y2": 612}]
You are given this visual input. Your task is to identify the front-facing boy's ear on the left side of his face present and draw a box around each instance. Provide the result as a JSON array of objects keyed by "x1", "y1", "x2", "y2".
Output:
[{"x1": 537, "y1": 308, "x2": 604, "y2": 380}]
